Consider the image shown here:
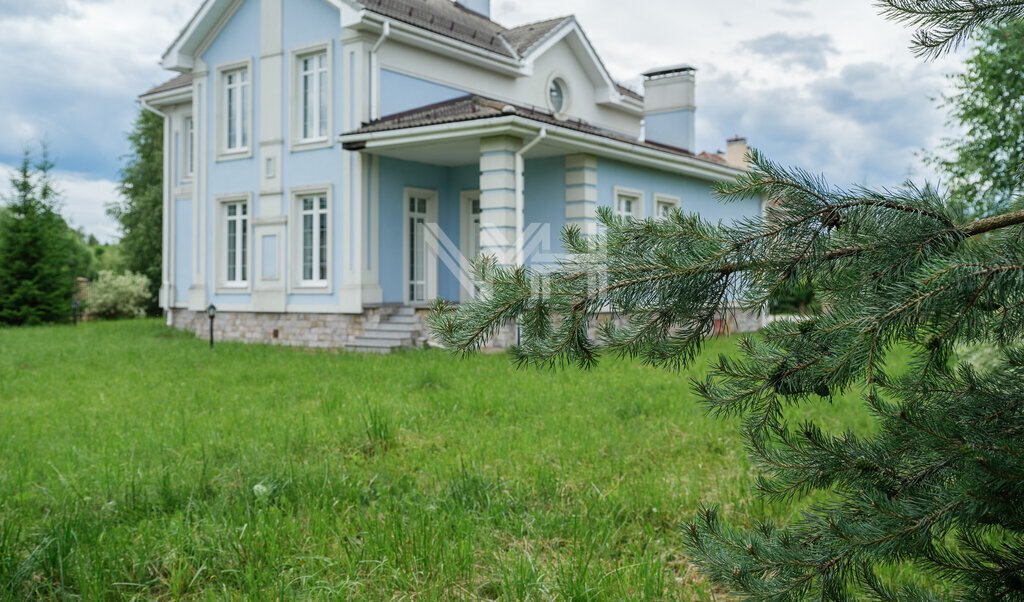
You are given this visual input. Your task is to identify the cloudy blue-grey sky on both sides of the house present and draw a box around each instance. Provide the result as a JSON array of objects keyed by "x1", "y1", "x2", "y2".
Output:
[{"x1": 0, "y1": 0, "x2": 964, "y2": 241}]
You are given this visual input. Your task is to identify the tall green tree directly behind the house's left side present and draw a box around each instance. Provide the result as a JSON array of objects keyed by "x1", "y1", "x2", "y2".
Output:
[{"x1": 106, "y1": 110, "x2": 164, "y2": 313}]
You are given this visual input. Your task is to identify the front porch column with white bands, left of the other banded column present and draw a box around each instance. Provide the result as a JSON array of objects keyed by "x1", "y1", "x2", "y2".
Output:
[{"x1": 480, "y1": 136, "x2": 522, "y2": 265}]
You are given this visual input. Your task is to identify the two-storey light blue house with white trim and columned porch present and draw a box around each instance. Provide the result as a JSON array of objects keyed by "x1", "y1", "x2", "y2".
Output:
[{"x1": 140, "y1": 0, "x2": 761, "y2": 349}]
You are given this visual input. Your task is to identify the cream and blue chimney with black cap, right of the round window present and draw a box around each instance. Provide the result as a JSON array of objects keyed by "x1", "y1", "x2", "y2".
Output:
[{"x1": 643, "y1": 65, "x2": 697, "y2": 153}]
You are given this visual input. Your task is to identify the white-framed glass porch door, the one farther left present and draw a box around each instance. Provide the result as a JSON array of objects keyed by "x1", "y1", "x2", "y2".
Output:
[{"x1": 404, "y1": 188, "x2": 437, "y2": 305}]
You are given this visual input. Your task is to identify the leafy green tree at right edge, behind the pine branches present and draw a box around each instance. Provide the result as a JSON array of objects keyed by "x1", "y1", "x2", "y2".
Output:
[{"x1": 929, "y1": 22, "x2": 1024, "y2": 215}]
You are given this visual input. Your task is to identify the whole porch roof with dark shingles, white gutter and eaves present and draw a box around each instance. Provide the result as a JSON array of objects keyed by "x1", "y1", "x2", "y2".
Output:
[{"x1": 340, "y1": 94, "x2": 739, "y2": 179}]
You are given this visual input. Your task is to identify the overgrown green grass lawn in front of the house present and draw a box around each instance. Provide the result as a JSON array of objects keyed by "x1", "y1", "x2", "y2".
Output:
[{"x1": 0, "y1": 320, "x2": 871, "y2": 600}]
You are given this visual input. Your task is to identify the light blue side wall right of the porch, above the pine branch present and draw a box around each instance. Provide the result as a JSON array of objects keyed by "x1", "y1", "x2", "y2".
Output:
[{"x1": 597, "y1": 159, "x2": 761, "y2": 223}]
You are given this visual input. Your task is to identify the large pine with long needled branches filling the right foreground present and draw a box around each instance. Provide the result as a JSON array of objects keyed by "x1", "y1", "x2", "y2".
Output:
[{"x1": 430, "y1": 0, "x2": 1024, "y2": 600}]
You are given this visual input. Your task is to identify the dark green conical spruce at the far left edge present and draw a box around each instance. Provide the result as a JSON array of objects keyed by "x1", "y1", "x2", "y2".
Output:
[{"x1": 0, "y1": 147, "x2": 84, "y2": 326}]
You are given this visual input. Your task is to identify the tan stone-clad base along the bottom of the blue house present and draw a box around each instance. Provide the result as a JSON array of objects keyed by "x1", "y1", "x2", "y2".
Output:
[{"x1": 171, "y1": 307, "x2": 762, "y2": 349}]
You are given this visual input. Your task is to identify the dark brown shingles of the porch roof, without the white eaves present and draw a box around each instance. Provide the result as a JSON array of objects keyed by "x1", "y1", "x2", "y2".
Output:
[{"x1": 345, "y1": 94, "x2": 723, "y2": 166}]
